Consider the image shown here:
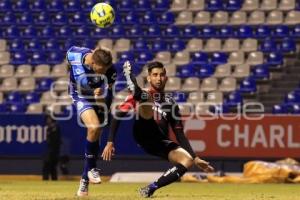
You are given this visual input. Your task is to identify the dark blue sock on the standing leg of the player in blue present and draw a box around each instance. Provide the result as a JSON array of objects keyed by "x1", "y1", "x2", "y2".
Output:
[{"x1": 82, "y1": 140, "x2": 99, "y2": 180}]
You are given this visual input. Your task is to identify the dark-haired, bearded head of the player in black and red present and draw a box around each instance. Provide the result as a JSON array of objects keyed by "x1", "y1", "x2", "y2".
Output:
[{"x1": 147, "y1": 61, "x2": 168, "y2": 91}]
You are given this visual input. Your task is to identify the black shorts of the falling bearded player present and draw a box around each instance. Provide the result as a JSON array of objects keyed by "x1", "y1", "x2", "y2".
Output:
[{"x1": 133, "y1": 117, "x2": 179, "y2": 160}]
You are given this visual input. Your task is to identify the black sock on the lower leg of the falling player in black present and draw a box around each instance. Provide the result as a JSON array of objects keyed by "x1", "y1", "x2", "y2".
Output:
[{"x1": 154, "y1": 164, "x2": 187, "y2": 189}]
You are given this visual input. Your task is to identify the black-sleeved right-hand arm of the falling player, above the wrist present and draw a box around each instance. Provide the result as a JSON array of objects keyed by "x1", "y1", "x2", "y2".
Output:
[{"x1": 171, "y1": 105, "x2": 196, "y2": 159}]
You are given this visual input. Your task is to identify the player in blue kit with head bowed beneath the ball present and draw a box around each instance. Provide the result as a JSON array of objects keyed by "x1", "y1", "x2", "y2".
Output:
[{"x1": 67, "y1": 46, "x2": 116, "y2": 196}]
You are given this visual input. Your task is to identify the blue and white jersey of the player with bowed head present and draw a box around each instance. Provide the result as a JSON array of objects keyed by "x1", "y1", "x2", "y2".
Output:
[{"x1": 67, "y1": 46, "x2": 117, "y2": 99}]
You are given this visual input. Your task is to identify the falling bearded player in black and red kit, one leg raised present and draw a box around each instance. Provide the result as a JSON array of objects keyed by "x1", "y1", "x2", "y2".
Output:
[{"x1": 102, "y1": 61, "x2": 214, "y2": 197}]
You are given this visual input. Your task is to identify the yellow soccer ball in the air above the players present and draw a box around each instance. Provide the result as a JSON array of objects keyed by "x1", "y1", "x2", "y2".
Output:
[{"x1": 90, "y1": 3, "x2": 115, "y2": 28}]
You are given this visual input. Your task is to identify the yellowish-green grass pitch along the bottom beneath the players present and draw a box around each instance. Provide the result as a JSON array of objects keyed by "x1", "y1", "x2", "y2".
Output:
[{"x1": 0, "y1": 180, "x2": 300, "y2": 200}]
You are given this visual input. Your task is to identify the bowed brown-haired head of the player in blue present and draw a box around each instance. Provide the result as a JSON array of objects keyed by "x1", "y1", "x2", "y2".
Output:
[{"x1": 91, "y1": 48, "x2": 112, "y2": 74}]
